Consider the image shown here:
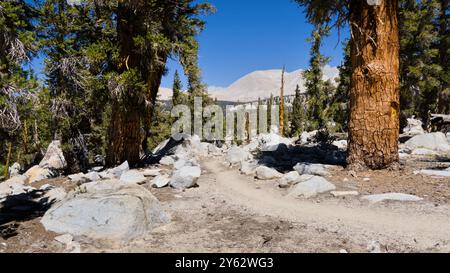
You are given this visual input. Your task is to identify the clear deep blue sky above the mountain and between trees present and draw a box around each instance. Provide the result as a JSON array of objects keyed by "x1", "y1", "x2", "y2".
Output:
[{"x1": 32, "y1": 0, "x2": 348, "y2": 87}]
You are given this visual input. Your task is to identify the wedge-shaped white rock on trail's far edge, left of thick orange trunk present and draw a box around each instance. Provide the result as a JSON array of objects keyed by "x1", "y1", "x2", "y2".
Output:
[{"x1": 288, "y1": 176, "x2": 336, "y2": 198}]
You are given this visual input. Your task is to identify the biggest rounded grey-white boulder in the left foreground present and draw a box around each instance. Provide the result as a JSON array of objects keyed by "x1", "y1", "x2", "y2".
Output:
[{"x1": 41, "y1": 181, "x2": 170, "y2": 243}]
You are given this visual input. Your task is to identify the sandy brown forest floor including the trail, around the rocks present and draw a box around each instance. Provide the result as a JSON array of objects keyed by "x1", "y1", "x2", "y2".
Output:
[{"x1": 0, "y1": 154, "x2": 450, "y2": 253}]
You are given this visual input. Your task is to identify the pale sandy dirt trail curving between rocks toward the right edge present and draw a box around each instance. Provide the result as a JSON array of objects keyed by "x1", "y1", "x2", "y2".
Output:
[{"x1": 199, "y1": 160, "x2": 450, "y2": 251}]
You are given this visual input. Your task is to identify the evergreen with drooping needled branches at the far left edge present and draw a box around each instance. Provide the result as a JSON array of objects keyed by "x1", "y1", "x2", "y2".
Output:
[{"x1": 0, "y1": 0, "x2": 38, "y2": 170}]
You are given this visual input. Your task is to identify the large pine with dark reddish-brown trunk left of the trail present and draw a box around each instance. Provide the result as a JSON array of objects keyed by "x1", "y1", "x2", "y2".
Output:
[{"x1": 107, "y1": 0, "x2": 211, "y2": 166}]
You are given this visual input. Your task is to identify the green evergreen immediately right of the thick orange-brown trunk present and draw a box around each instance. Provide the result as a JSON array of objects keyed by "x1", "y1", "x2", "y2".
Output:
[{"x1": 399, "y1": 0, "x2": 442, "y2": 121}]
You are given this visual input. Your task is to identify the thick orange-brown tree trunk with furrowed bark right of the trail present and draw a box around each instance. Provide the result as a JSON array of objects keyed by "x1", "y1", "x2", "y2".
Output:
[{"x1": 347, "y1": 0, "x2": 400, "y2": 169}]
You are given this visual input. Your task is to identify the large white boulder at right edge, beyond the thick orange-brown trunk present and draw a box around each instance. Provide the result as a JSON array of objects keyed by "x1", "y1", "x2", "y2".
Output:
[{"x1": 405, "y1": 132, "x2": 450, "y2": 152}]
